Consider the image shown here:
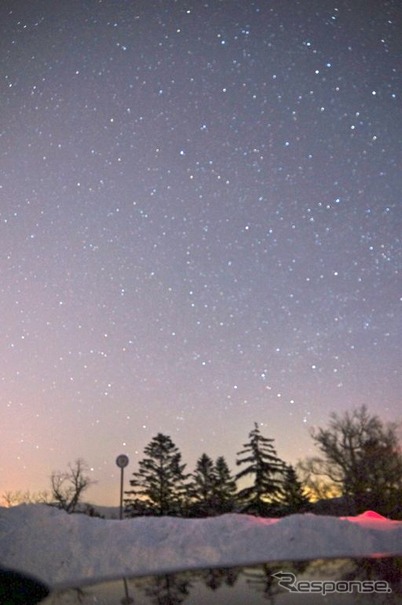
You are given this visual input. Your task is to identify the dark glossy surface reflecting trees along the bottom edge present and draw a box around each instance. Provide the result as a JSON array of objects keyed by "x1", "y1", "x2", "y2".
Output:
[{"x1": 41, "y1": 557, "x2": 402, "y2": 605}]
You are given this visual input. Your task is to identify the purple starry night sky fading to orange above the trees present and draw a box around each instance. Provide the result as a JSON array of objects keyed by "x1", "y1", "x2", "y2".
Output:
[{"x1": 0, "y1": 0, "x2": 402, "y2": 504}]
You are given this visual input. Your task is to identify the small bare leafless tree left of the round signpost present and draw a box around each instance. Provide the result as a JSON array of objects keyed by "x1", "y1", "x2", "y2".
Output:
[{"x1": 50, "y1": 458, "x2": 95, "y2": 513}]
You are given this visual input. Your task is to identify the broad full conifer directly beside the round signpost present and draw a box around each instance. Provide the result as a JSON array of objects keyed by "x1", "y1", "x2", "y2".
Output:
[{"x1": 125, "y1": 433, "x2": 188, "y2": 515}]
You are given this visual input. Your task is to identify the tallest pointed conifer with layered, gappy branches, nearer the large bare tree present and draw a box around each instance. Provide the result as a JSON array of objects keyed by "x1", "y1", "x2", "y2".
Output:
[{"x1": 236, "y1": 423, "x2": 285, "y2": 516}]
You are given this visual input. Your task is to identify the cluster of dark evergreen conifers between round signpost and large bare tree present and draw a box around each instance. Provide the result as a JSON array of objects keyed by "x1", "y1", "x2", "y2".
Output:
[{"x1": 125, "y1": 423, "x2": 309, "y2": 517}]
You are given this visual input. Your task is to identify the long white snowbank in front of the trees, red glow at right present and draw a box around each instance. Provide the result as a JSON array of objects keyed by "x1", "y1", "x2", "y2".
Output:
[{"x1": 0, "y1": 505, "x2": 402, "y2": 586}]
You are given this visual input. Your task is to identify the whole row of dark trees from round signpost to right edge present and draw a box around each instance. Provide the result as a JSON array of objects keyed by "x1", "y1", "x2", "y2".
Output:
[{"x1": 124, "y1": 406, "x2": 402, "y2": 518}]
